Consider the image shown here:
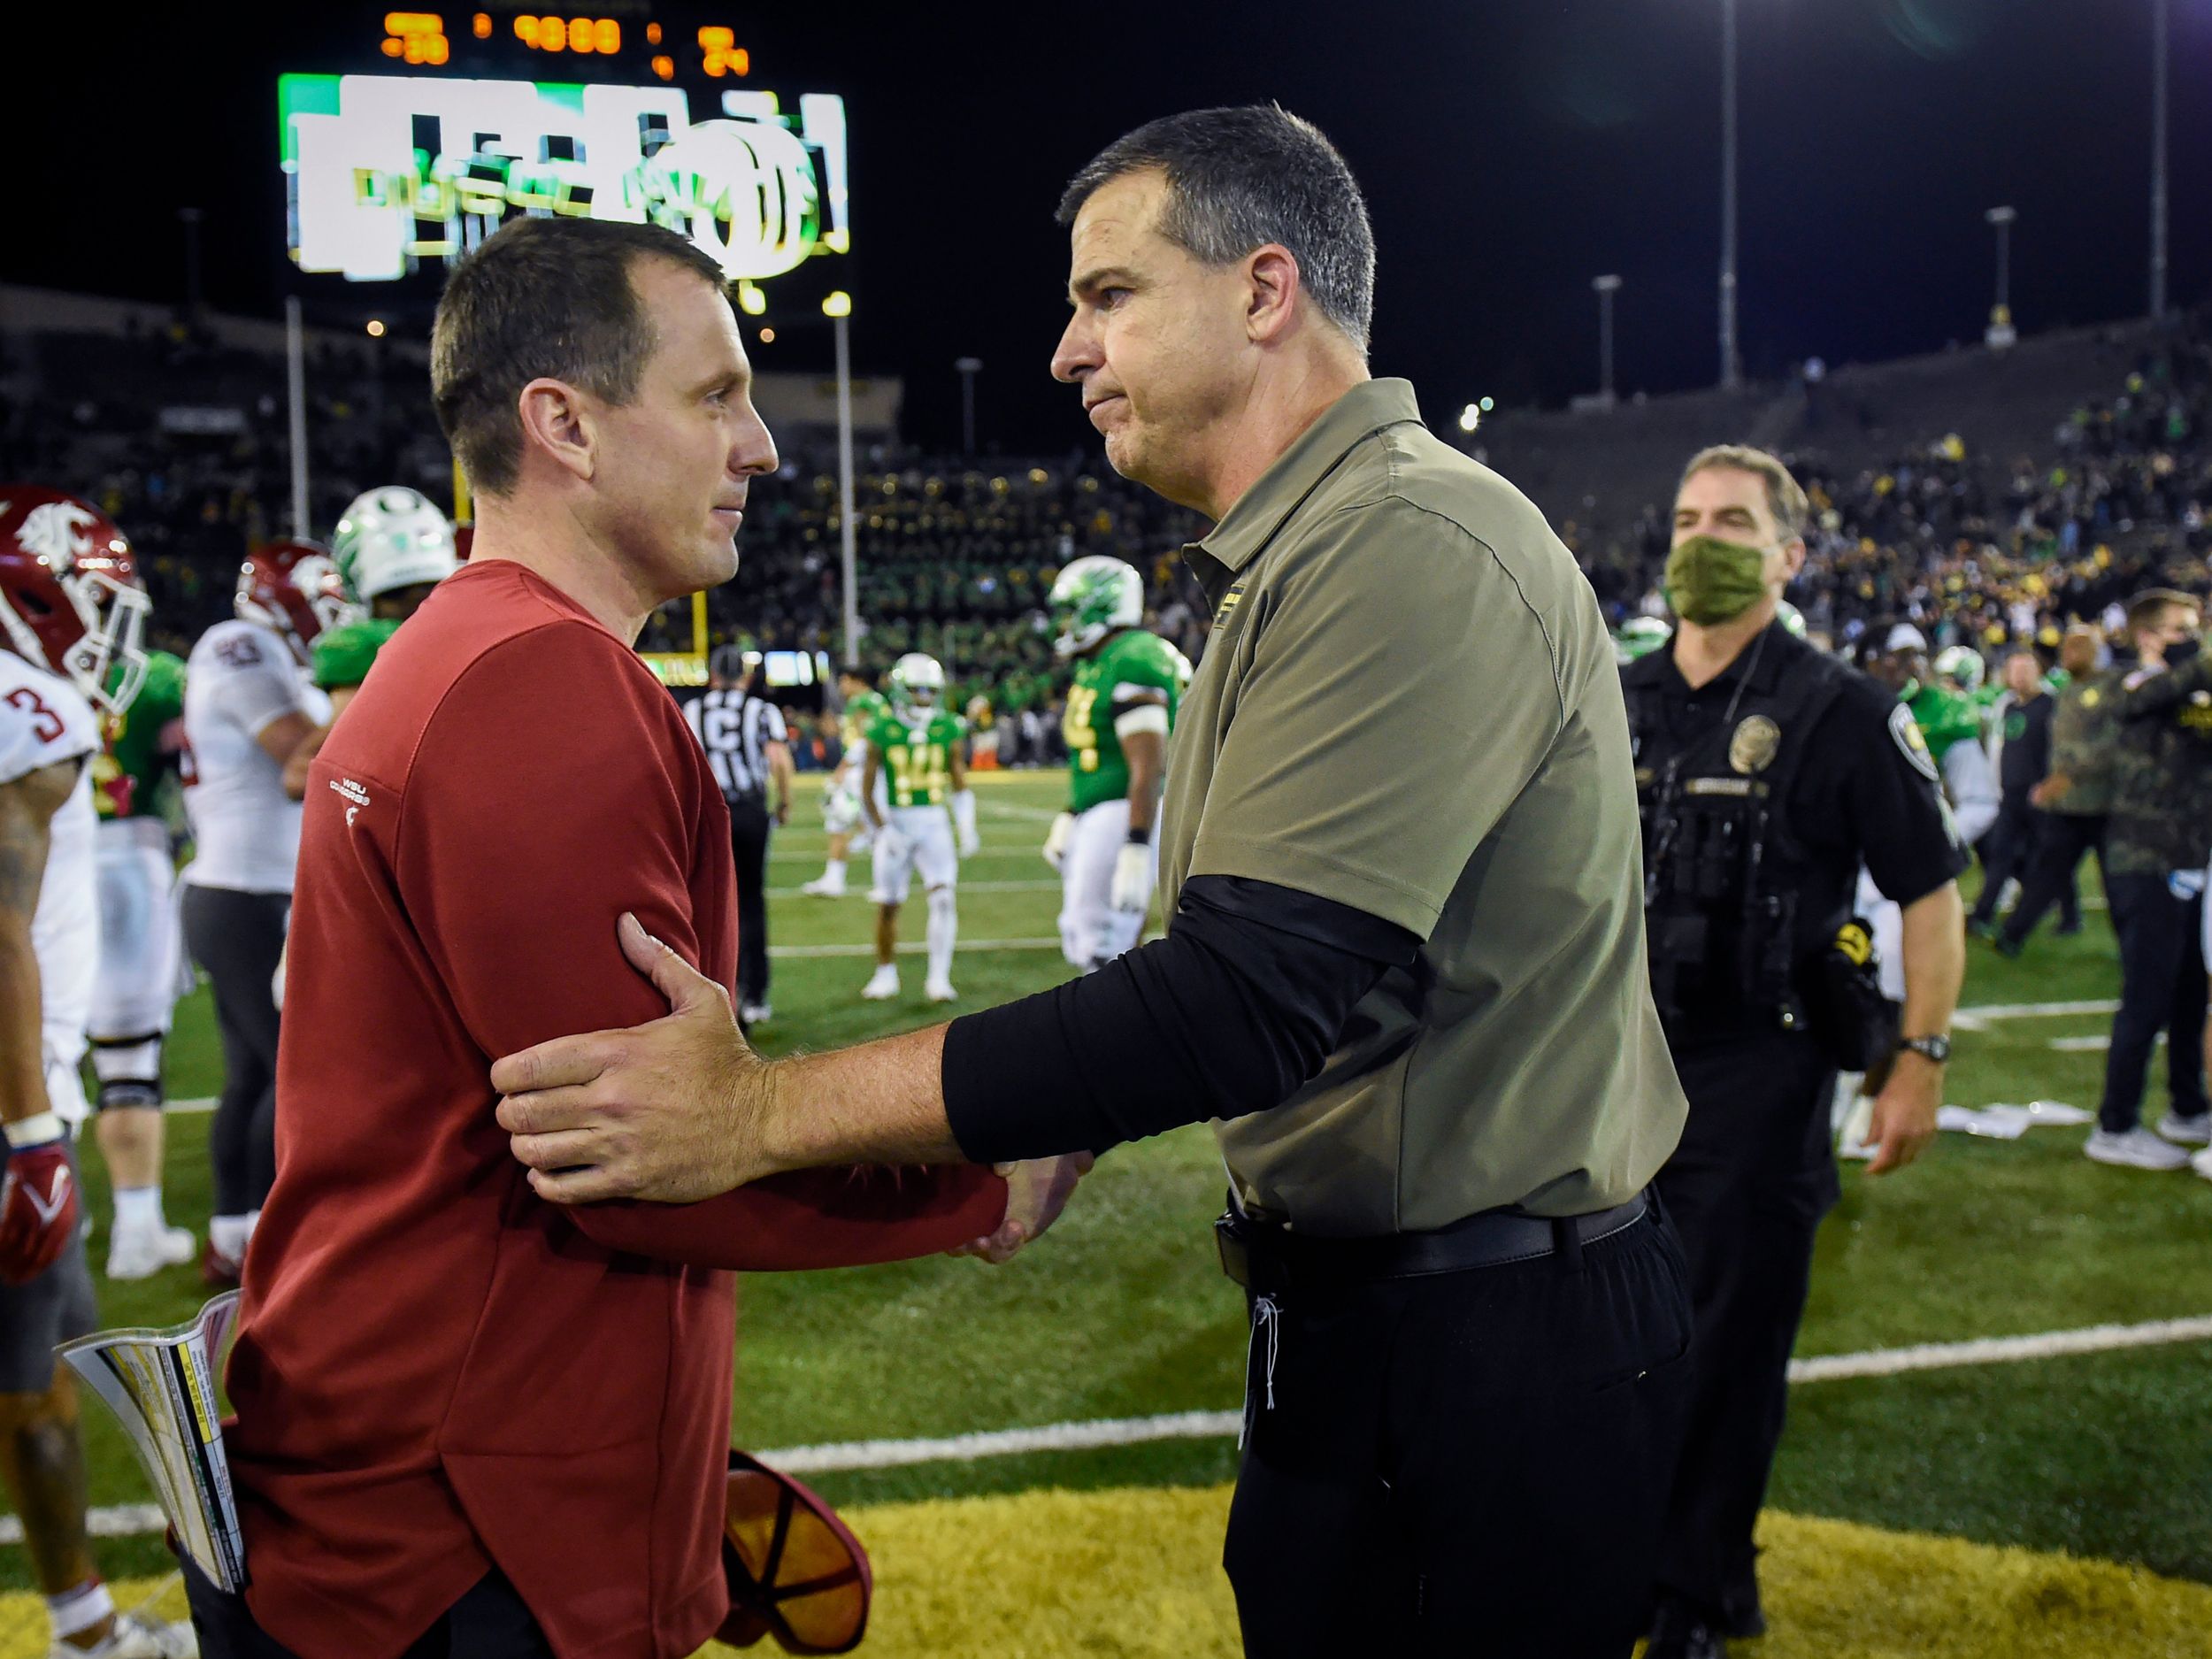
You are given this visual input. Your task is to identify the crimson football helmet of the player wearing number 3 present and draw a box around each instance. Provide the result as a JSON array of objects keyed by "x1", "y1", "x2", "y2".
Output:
[{"x1": 0, "y1": 485, "x2": 153, "y2": 715}]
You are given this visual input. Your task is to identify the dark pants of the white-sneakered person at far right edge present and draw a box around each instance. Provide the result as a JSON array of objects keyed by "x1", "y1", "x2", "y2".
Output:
[{"x1": 2097, "y1": 876, "x2": 2206, "y2": 1135}]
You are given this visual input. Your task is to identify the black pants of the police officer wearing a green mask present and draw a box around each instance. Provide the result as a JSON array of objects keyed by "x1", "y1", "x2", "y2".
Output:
[{"x1": 1657, "y1": 1035, "x2": 1839, "y2": 1635}]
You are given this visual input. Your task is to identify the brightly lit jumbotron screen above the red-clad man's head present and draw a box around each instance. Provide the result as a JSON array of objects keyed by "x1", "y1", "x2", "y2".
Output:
[{"x1": 277, "y1": 75, "x2": 852, "y2": 283}]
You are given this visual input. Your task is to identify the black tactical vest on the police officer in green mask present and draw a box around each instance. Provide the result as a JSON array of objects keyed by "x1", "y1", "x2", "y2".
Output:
[{"x1": 1626, "y1": 635, "x2": 1849, "y2": 1031}]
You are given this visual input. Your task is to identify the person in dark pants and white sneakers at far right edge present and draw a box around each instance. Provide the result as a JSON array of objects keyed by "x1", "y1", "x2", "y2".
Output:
[{"x1": 2082, "y1": 588, "x2": 2212, "y2": 1171}]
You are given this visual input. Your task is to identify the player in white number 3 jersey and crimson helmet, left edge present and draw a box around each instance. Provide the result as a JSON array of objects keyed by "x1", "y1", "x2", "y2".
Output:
[{"x1": 0, "y1": 487, "x2": 197, "y2": 1659}]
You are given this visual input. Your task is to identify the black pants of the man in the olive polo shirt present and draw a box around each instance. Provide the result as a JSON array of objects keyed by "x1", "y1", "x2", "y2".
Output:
[{"x1": 1224, "y1": 1208, "x2": 1690, "y2": 1659}]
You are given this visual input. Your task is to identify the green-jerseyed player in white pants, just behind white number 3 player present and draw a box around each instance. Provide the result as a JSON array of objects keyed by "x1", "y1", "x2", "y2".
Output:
[{"x1": 87, "y1": 650, "x2": 197, "y2": 1279}]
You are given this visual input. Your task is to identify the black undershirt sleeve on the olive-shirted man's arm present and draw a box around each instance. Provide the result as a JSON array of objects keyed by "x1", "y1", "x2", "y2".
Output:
[{"x1": 942, "y1": 876, "x2": 1420, "y2": 1164}]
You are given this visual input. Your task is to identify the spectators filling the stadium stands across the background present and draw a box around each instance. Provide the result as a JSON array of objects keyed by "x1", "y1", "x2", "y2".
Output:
[{"x1": 17, "y1": 312, "x2": 2212, "y2": 765}]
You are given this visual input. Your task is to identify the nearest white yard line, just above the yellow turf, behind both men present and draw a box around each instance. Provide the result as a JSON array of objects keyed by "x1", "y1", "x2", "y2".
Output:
[{"x1": 0, "y1": 1317, "x2": 2212, "y2": 1544}]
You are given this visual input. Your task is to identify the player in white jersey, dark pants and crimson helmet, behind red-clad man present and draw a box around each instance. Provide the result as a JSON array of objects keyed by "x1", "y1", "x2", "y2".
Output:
[{"x1": 184, "y1": 542, "x2": 342, "y2": 1286}]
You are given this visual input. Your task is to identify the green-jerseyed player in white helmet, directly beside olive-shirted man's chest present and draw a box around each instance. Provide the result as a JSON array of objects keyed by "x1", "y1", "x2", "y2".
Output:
[{"x1": 1044, "y1": 553, "x2": 1190, "y2": 973}]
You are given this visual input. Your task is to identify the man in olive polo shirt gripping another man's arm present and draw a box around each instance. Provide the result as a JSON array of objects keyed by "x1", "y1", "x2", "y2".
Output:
[{"x1": 494, "y1": 106, "x2": 1690, "y2": 1659}]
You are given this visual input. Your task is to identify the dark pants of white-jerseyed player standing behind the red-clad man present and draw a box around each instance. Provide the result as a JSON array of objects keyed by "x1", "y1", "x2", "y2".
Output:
[{"x1": 184, "y1": 885, "x2": 292, "y2": 1215}]
